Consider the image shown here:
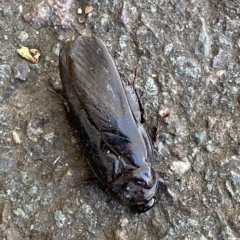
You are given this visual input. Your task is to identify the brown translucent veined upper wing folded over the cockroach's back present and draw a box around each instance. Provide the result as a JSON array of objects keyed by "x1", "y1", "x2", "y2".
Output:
[{"x1": 60, "y1": 37, "x2": 151, "y2": 166}]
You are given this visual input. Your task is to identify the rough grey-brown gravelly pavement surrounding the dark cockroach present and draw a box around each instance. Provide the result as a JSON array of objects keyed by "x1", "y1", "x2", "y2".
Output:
[{"x1": 0, "y1": 0, "x2": 240, "y2": 240}]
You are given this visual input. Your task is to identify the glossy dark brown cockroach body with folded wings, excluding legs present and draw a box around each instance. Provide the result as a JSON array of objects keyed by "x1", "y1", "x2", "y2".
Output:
[{"x1": 59, "y1": 36, "x2": 158, "y2": 212}]
